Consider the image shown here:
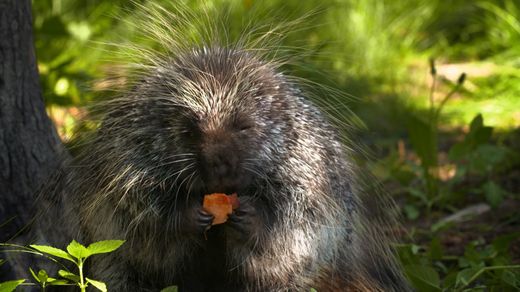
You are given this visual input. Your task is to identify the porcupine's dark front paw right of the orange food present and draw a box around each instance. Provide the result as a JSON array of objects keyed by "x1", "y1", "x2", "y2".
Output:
[{"x1": 227, "y1": 198, "x2": 262, "y2": 240}]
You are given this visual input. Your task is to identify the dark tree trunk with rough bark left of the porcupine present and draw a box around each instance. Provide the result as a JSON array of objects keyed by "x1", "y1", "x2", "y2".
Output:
[{"x1": 0, "y1": 0, "x2": 62, "y2": 242}]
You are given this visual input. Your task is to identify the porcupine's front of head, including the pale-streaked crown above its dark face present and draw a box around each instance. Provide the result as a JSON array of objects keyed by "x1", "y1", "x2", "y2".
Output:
[{"x1": 148, "y1": 49, "x2": 283, "y2": 195}]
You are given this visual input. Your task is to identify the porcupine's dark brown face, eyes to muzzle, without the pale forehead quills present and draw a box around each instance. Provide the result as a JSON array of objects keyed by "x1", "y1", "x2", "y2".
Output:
[{"x1": 177, "y1": 94, "x2": 262, "y2": 194}]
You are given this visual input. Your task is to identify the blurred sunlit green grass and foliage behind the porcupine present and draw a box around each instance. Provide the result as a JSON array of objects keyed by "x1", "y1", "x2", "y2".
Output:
[{"x1": 33, "y1": 0, "x2": 520, "y2": 291}]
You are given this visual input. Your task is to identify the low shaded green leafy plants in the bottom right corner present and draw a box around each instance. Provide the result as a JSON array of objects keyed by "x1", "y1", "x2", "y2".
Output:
[{"x1": 398, "y1": 233, "x2": 520, "y2": 291}]
